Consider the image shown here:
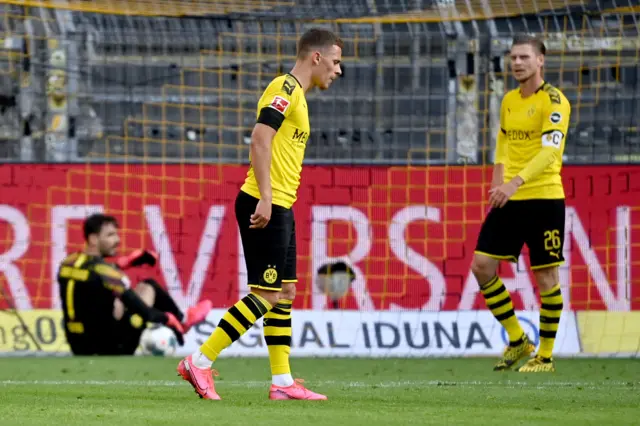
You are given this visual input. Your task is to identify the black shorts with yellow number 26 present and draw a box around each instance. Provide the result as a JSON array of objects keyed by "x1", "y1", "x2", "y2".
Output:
[{"x1": 475, "y1": 199, "x2": 565, "y2": 269}]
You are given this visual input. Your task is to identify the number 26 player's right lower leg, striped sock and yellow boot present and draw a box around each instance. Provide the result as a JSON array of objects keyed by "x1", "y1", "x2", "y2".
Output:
[{"x1": 518, "y1": 267, "x2": 563, "y2": 373}]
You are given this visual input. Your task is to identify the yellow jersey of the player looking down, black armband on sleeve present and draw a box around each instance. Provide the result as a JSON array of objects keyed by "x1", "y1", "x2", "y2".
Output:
[{"x1": 241, "y1": 74, "x2": 311, "y2": 208}]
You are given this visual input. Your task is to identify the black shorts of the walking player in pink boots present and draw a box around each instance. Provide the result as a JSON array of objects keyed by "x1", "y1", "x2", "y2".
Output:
[{"x1": 236, "y1": 191, "x2": 298, "y2": 291}]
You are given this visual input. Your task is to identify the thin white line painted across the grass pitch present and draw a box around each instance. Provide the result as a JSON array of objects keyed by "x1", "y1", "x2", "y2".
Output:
[{"x1": 0, "y1": 380, "x2": 640, "y2": 389}]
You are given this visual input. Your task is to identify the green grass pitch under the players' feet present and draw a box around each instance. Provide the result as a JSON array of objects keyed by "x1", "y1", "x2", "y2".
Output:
[{"x1": 0, "y1": 357, "x2": 640, "y2": 426}]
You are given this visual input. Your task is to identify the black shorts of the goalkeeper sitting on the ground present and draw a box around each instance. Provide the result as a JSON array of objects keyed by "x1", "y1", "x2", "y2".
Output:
[{"x1": 67, "y1": 311, "x2": 145, "y2": 355}]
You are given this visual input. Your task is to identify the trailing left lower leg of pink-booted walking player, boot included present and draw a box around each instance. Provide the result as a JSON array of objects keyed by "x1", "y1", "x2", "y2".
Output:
[{"x1": 178, "y1": 292, "x2": 273, "y2": 399}]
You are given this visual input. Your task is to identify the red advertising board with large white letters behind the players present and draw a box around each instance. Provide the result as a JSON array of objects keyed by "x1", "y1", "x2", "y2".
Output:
[{"x1": 0, "y1": 165, "x2": 640, "y2": 310}]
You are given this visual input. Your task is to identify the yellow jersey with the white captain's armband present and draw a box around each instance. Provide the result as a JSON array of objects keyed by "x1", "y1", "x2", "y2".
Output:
[{"x1": 495, "y1": 83, "x2": 571, "y2": 200}]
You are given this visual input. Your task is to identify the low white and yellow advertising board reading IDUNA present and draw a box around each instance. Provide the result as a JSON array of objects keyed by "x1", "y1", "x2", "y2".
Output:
[{"x1": 5, "y1": 309, "x2": 640, "y2": 357}]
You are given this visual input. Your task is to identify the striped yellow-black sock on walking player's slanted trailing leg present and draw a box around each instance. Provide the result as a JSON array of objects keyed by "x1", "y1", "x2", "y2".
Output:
[{"x1": 200, "y1": 293, "x2": 271, "y2": 361}]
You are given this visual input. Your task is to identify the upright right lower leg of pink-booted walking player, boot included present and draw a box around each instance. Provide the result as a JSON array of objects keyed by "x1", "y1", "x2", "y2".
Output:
[{"x1": 263, "y1": 296, "x2": 327, "y2": 401}]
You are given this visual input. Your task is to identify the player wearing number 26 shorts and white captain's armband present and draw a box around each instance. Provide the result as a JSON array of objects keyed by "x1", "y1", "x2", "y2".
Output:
[{"x1": 472, "y1": 36, "x2": 571, "y2": 372}]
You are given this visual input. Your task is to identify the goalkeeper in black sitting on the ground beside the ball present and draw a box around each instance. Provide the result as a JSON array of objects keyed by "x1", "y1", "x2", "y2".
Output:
[{"x1": 58, "y1": 214, "x2": 211, "y2": 355}]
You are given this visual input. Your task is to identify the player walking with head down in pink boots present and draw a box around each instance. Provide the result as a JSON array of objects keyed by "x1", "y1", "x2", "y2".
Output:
[{"x1": 178, "y1": 29, "x2": 342, "y2": 400}]
